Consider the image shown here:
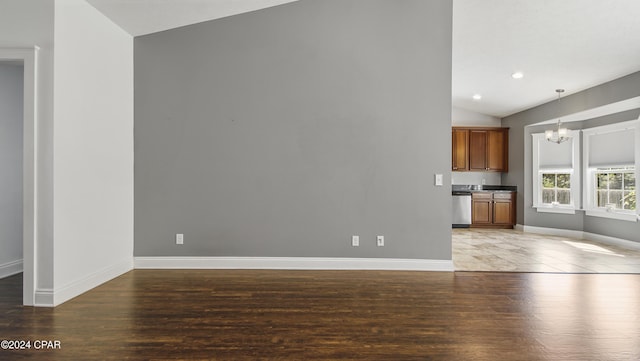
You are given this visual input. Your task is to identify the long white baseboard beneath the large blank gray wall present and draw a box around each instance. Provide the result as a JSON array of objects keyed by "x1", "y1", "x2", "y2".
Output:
[{"x1": 134, "y1": 257, "x2": 454, "y2": 272}]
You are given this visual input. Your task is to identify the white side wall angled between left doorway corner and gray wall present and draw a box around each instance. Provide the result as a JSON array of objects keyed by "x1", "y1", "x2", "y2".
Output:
[{"x1": 53, "y1": 0, "x2": 133, "y2": 304}]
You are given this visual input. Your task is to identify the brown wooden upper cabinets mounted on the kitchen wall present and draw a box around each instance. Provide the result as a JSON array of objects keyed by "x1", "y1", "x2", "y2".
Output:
[{"x1": 451, "y1": 127, "x2": 509, "y2": 172}]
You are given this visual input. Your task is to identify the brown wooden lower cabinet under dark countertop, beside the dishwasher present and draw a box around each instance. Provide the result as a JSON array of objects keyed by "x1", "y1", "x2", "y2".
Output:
[{"x1": 471, "y1": 192, "x2": 516, "y2": 228}]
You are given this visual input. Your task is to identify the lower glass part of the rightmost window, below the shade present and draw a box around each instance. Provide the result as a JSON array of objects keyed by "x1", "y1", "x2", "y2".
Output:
[{"x1": 594, "y1": 166, "x2": 636, "y2": 212}]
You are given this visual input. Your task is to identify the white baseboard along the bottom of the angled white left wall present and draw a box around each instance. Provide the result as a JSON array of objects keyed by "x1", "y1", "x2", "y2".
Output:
[{"x1": 35, "y1": 258, "x2": 133, "y2": 307}]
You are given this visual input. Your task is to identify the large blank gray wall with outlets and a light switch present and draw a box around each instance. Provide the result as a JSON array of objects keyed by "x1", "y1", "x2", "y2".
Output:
[{"x1": 134, "y1": 0, "x2": 452, "y2": 260}]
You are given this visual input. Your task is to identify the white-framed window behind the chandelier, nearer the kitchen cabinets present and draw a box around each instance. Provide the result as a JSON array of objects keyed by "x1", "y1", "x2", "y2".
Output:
[{"x1": 532, "y1": 131, "x2": 581, "y2": 214}]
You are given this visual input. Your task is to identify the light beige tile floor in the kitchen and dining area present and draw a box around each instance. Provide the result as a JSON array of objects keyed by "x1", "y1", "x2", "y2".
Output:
[{"x1": 453, "y1": 228, "x2": 640, "y2": 273}]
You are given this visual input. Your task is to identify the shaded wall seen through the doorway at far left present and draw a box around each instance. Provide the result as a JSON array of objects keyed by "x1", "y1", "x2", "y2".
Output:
[{"x1": 0, "y1": 62, "x2": 23, "y2": 278}]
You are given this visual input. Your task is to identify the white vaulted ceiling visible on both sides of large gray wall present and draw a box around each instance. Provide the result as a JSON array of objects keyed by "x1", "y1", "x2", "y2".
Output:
[{"x1": 88, "y1": 0, "x2": 640, "y2": 117}]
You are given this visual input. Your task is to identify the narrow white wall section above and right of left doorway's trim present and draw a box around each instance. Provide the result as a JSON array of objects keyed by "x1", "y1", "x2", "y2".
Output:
[{"x1": 0, "y1": 0, "x2": 54, "y2": 296}]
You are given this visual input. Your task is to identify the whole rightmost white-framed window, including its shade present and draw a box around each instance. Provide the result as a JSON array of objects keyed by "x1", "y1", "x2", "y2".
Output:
[{"x1": 583, "y1": 121, "x2": 640, "y2": 222}]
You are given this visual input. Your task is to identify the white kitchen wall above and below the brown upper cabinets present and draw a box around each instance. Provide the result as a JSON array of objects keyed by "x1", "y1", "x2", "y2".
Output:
[{"x1": 451, "y1": 107, "x2": 501, "y2": 185}]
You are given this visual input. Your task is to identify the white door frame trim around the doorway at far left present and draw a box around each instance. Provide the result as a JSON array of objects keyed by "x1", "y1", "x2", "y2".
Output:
[{"x1": 0, "y1": 46, "x2": 39, "y2": 306}]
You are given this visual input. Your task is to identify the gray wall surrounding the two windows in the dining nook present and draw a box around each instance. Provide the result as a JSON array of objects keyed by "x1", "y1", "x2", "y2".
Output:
[{"x1": 502, "y1": 72, "x2": 640, "y2": 241}]
